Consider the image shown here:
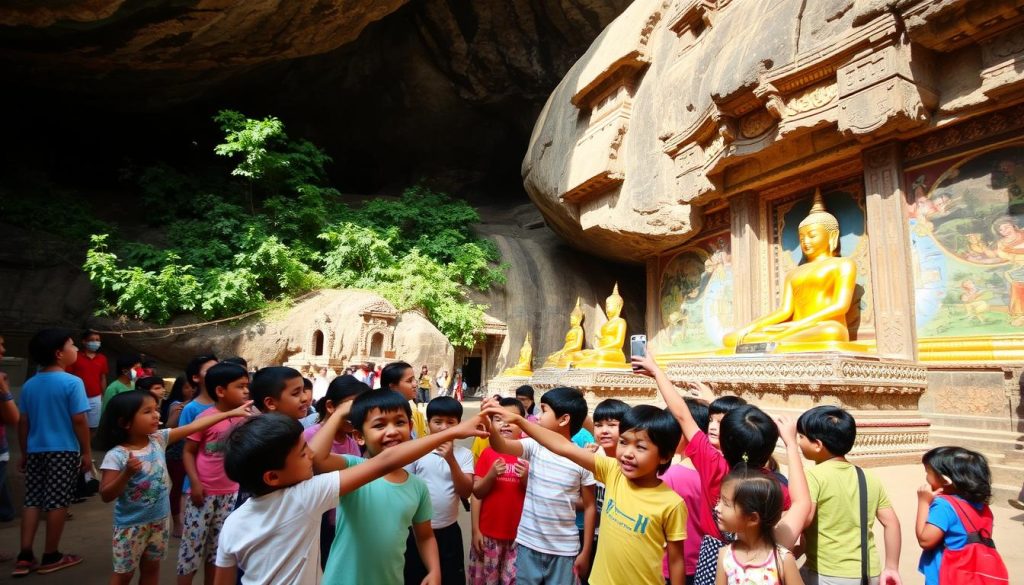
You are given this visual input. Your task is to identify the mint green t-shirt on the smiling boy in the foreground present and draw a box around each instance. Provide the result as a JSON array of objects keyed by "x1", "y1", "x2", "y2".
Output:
[{"x1": 323, "y1": 455, "x2": 433, "y2": 585}]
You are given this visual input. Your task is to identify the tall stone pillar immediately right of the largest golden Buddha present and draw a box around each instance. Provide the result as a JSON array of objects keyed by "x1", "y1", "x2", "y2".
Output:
[{"x1": 863, "y1": 142, "x2": 918, "y2": 360}]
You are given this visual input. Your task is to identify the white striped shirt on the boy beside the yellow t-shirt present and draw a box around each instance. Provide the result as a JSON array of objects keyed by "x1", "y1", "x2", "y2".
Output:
[{"x1": 515, "y1": 438, "x2": 596, "y2": 556}]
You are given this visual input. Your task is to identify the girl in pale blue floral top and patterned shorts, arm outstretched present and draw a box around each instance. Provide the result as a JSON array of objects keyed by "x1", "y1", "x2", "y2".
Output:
[{"x1": 97, "y1": 390, "x2": 251, "y2": 584}]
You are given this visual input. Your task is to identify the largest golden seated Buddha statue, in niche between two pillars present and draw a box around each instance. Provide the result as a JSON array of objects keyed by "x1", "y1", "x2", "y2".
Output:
[{"x1": 723, "y1": 191, "x2": 857, "y2": 350}]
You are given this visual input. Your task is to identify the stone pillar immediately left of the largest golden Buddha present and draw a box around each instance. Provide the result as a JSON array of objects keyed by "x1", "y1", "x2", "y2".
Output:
[{"x1": 729, "y1": 192, "x2": 763, "y2": 327}]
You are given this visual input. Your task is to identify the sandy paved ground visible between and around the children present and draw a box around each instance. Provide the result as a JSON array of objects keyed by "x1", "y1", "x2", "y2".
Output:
[{"x1": 0, "y1": 405, "x2": 1024, "y2": 585}]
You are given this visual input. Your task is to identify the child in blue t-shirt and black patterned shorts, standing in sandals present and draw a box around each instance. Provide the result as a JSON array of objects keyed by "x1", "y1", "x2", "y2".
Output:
[{"x1": 11, "y1": 329, "x2": 92, "y2": 577}]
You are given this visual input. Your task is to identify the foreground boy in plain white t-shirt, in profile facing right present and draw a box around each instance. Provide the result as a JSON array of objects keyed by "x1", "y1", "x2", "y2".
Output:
[{"x1": 214, "y1": 403, "x2": 481, "y2": 585}]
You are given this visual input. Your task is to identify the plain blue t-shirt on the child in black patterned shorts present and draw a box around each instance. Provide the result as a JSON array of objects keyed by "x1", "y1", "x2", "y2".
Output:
[{"x1": 18, "y1": 372, "x2": 89, "y2": 453}]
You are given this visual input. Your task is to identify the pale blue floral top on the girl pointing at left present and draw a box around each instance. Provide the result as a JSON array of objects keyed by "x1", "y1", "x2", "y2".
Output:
[{"x1": 99, "y1": 428, "x2": 171, "y2": 527}]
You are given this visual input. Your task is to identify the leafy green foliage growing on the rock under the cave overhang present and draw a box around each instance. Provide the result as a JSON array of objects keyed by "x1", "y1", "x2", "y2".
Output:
[{"x1": 85, "y1": 111, "x2": 505, "y2": 346}]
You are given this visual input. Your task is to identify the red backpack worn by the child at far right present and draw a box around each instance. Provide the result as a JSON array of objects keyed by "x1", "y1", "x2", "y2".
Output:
[{"x1": 939, "y1": 496, "x2": 1010, "y2": 585}]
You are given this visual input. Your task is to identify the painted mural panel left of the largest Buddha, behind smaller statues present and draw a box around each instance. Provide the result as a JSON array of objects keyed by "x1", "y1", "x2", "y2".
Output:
[{"x1": 655, "y1": 234, "x2": 733, "y2": 352}]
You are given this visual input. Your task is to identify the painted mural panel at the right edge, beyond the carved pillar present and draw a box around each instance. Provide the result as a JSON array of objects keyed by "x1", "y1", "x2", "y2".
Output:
[{"x1": 905, "y1": 144, "x2": 1024, "y2": 337}]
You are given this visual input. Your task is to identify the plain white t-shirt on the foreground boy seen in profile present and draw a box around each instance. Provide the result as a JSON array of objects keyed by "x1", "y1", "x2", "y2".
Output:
[{"x1": 216, "y1": 471, "x2": 340, "y2": 585}]
